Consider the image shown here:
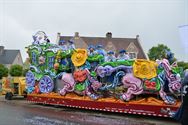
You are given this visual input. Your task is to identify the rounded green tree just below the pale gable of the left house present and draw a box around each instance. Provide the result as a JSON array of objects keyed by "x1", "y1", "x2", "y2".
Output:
[{"x1": 9, "y1": 65, "x2": 23, "y2": 76}]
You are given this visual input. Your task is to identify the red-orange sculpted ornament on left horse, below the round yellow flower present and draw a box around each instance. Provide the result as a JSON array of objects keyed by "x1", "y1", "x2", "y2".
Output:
[{"x1": 73, "y1": 70, "x2": 87, "y2": 82}]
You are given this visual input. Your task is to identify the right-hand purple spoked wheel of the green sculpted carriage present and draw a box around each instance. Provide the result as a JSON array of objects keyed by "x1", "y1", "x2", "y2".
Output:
[{"x1": 39, "y1": 75, "x2": 54, "y2": 93}]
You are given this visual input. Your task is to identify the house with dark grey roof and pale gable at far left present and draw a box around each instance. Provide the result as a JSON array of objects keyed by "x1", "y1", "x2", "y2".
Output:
[{"x1": 0, "y1": 46, "x2": 23, "y2": 68}]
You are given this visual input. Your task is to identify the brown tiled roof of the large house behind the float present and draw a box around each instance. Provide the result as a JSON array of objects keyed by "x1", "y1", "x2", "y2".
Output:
[{"x1": 59, "y1": 33, "x2": 146, "y2": 59}]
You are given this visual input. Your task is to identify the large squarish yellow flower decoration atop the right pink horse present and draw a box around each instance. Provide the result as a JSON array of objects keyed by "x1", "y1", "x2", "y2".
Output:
[{"x1": 133, "y1": 59, "x2": 157, "y2": 79}]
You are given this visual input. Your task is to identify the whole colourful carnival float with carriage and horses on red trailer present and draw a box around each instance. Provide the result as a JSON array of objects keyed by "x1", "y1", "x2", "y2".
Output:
[{"x1": 26, "y1": 31, "x2": 187, "y2": 117}]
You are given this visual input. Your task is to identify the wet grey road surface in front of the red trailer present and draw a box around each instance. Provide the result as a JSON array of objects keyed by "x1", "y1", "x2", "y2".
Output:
[{"x1": 0, "y1": 97, "x2": 180, "y2": 125}]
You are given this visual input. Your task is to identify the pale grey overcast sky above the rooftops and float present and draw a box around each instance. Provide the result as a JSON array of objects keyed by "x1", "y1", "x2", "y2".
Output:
[{"x1": 0, "y1": 0, "x2": 188, "y2": 61}]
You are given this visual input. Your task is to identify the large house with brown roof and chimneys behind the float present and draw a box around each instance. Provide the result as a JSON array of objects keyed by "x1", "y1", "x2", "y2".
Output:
[{"x1": 57, "y1": 32, "x2": 147, "y2": 59}]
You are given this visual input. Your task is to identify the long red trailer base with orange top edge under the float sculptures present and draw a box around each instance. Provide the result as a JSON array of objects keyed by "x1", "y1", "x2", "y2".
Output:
[{"x1": 27, "y1": 93, "x2": 181, "y2": 117}]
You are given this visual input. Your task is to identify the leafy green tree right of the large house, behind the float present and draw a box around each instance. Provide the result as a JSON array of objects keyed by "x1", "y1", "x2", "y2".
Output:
[{"x1": 148, "y1": 44, "x2": 174, "y2": 61}]
